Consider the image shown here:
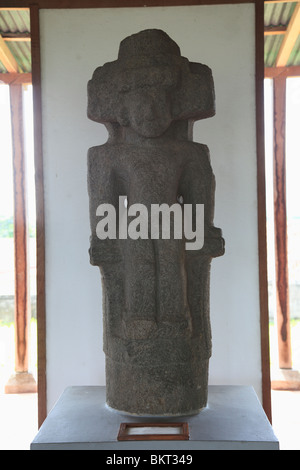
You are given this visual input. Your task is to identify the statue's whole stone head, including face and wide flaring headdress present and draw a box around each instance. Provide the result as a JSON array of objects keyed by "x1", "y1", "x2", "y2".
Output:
[{"x1": 88, "y1": 29, "x2": 215, "y2": 138}]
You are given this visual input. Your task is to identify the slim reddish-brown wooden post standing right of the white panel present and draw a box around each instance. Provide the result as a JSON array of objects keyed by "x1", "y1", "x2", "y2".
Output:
[{"x1": 273, "y1": 74, "x2": 292, "y2": 369}]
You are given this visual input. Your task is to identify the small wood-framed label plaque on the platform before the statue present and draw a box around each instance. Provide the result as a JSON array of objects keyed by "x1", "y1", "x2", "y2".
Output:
[{"x1": 118, "y1": 423, "x2": 189, "y2": 441}]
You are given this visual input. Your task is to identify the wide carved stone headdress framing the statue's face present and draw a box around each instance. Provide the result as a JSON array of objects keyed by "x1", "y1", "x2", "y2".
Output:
[{"x1": 88, "y1": 29, "x2": 215, "y2": 125}]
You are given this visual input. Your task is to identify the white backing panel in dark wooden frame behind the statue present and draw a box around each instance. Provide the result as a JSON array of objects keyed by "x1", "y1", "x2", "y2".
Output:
[{"x1": 40, "y1": 4, "x2": 261, "y2": 409}]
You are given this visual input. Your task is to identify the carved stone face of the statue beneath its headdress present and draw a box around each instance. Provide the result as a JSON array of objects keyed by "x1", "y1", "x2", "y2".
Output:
[{"x1": 119, "y1": 67, "x2": 179, "y2": 137}]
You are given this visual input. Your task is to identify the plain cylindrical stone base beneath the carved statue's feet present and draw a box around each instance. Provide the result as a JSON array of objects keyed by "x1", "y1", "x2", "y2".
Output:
[{"x1": 106, "y1": 357, "x2": 209, "y2": 416}]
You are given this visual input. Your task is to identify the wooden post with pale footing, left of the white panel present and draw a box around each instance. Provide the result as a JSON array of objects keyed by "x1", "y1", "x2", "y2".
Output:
[{"x1": 5, "y1": 85, "x2": 37, "y2": 393}]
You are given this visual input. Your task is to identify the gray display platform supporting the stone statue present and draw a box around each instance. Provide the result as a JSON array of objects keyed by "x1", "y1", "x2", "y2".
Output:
[{"x1": 30, "y1": 385, "x2": 279, "y2": 451}]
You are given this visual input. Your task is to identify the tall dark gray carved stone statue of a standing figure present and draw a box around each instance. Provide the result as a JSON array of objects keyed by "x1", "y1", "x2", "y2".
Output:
[{"x1": 88, "y1": 29, "x2": 224, "y2": 416}]
